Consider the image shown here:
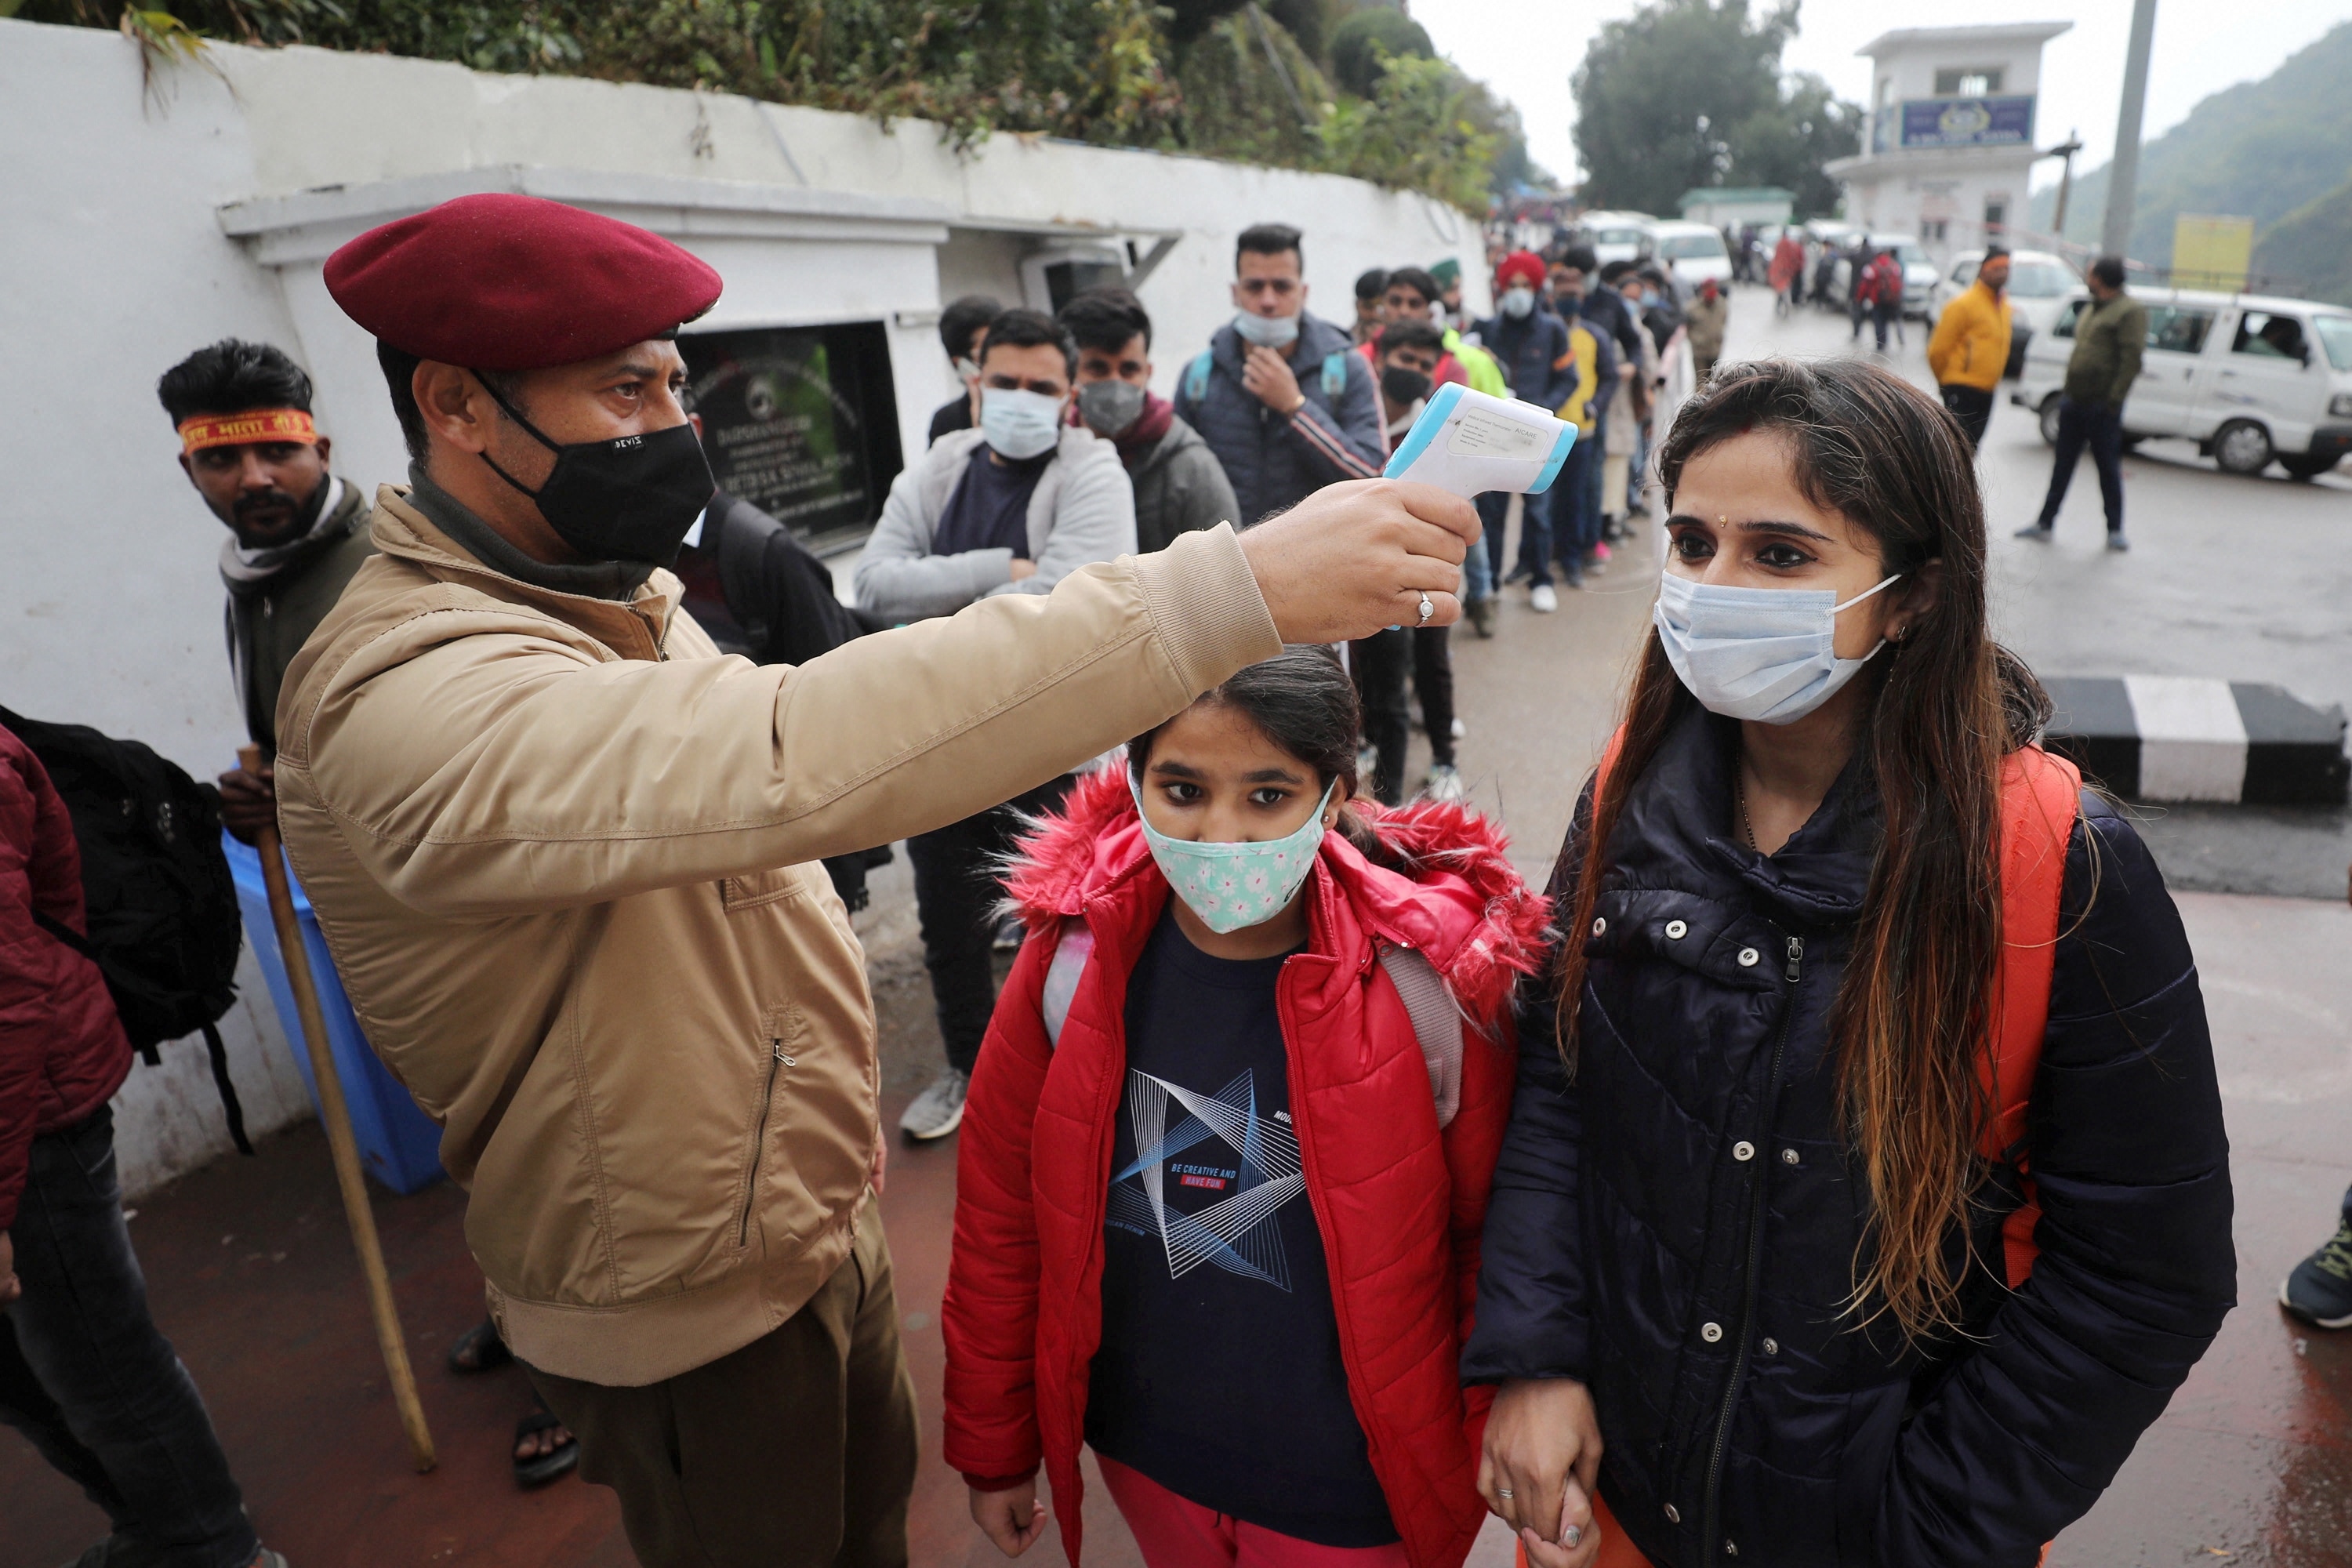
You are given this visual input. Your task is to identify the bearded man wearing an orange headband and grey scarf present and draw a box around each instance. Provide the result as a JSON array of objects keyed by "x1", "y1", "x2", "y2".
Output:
[{"x1": 155, "y1": 339, "x2": 376, "y2": 844}]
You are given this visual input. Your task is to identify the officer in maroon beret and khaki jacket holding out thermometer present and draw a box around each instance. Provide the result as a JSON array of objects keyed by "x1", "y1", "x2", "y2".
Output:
[{"x1": 278, "y1": 195, "x2": 1477, "y2": 1568}]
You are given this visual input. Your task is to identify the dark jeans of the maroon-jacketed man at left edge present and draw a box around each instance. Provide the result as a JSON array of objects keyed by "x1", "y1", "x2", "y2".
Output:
[{"x1": 0, "y1": 1109, "x2": 261, "y2": 1568}]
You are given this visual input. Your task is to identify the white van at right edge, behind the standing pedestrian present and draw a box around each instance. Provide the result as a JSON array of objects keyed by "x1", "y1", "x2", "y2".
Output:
[{"x1": 2009, "y1": 289, "x2": 2352, "y2": 480}]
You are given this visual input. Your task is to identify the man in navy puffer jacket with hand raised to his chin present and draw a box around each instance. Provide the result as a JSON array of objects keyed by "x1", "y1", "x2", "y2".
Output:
[{"x1": 1176, "y1": 223, "x2": 1383, "y2": 524}]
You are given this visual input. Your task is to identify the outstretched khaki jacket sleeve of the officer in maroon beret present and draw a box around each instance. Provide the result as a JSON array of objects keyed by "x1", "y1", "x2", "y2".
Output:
[{"x1": 301, "y1": 529, "x2": 1282, "y2": 919}]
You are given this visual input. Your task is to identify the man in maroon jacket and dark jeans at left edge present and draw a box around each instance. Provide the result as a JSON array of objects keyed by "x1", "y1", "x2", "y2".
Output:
[{"x1": 0, "y1": 729, "x2": 285, "y2": 1568}]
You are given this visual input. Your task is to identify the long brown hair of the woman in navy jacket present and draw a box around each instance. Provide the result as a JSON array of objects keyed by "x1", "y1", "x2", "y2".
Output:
[{"x1": 1559, "y1": 360, "x2": 2051, "y2": 1340}]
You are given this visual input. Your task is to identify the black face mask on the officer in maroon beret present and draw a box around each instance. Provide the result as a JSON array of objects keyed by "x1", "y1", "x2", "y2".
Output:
[{"x1": 468, "y1": 381, "x2": 717, "y2": 567}]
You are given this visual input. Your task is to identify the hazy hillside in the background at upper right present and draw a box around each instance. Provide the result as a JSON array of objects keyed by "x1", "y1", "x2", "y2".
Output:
[{"x1": 2034, "y1": 24, "x2": 2352, "y2": 303}]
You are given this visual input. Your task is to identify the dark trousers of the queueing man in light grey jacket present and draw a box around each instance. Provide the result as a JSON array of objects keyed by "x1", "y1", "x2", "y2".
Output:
[{"x1": 906, "y1": 776, "x2": 1070, "y2": 1072}]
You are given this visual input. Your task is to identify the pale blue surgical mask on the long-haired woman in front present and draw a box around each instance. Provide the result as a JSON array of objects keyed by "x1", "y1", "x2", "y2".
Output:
[{"x1": 1651, "y1": 572, "x2": 1903, "y2": 724}]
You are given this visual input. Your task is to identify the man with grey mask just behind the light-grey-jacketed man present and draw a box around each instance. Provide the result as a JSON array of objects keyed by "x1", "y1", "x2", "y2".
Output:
[{"x1": 1061, "y1": 287, "x2": 1242, "y2": 550}]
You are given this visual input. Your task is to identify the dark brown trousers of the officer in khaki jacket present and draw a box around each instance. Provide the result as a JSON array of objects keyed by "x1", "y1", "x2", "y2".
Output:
[{"x1": 524, "y1": 1208, "x2": 917, "y2": 1568}]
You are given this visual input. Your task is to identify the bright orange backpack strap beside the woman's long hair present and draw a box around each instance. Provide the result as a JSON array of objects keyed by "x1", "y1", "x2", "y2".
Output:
[{"x1": 1978, "y1": 746, "x2": 2082, "y2": 1290}]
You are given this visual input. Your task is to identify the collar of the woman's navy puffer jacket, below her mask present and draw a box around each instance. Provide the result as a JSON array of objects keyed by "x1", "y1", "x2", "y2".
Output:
[{"x1": 1609, "y1": 703, "x2": 1877, "y2": 924}]
